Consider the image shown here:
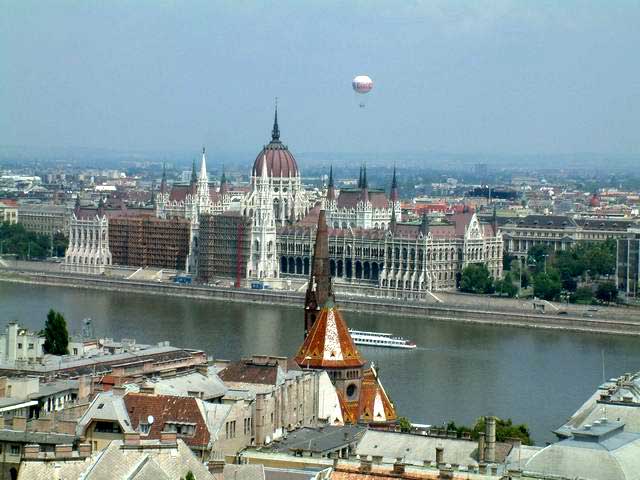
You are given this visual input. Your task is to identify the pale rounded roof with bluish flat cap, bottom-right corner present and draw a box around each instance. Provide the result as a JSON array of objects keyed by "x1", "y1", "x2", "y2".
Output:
[{"x1": 523, "y1": 422, "x2": 640, "y2": 480}]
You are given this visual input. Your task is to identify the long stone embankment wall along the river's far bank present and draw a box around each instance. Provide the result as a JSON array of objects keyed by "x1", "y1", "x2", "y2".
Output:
[{"x1": 0, "y1": 270, "x2": 640, "y2": 336}]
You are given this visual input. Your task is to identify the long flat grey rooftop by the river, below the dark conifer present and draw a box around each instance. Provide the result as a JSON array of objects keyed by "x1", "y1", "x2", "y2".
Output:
[{"x1": 0, "y1": 342, "x2": 207, "y2": 378}]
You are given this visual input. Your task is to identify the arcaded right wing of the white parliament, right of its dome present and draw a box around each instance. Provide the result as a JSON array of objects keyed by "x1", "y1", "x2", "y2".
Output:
[{"x1": 278, "y1": 213, "x2": 503, "y2": 298}]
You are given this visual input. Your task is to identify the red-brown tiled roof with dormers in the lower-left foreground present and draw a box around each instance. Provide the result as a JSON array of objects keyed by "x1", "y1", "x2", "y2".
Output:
[{"x1": 124, "y1": 393, "x2": 210, "y2": 447}]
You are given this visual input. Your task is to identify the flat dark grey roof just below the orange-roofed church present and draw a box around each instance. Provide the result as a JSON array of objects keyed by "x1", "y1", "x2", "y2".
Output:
[{"x1": 271, "y1": 425, "x2": 366, "y2": 453}]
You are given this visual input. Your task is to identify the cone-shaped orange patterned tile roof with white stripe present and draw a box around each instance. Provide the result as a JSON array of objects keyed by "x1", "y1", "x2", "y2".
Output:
[{"x1": 295, "y1": 303, "x2": 364, "y2": 368}]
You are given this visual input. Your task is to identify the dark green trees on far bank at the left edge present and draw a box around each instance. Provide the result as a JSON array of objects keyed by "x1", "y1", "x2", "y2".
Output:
[{"x1": 0, "y1": 222, "x2": 68, "y2": 260}]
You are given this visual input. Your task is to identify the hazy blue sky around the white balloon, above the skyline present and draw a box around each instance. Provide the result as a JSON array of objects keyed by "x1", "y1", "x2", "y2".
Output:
[{"x1": 0, "y1": 0, "x2": 640, "y2": 154}]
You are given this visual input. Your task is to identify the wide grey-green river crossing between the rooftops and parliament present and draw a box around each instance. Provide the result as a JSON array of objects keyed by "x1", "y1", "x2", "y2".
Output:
[{"x1": 0, "y1": 282, "x2": 640, "y2": 444}]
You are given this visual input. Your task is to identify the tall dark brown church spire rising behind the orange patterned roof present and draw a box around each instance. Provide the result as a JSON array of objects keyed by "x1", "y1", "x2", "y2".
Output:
[{"x1": 304, "y1": 210, "x2": 335, "y2": 338}]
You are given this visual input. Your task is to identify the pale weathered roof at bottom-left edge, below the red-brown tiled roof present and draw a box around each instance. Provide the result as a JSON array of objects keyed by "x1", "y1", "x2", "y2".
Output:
[{"x1": 18, "y1": 440, "x2": 213, "y2": 480}]
